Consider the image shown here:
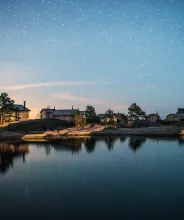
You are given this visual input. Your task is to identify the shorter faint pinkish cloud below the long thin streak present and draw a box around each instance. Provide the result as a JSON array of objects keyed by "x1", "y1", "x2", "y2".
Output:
[{"x1": 52, "y1": 92, "x2": 105, "y2": 105}]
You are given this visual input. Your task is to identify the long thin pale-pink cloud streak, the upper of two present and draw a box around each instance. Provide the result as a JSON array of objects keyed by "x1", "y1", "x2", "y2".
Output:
[{"x1": 3, "y1": 81, "x2": 109, "y2": 90}]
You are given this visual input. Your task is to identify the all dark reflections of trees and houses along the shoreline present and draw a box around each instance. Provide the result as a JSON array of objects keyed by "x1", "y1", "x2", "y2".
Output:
[{"x1": 0, "y1": 136, "x2": 184, "y2": 174}]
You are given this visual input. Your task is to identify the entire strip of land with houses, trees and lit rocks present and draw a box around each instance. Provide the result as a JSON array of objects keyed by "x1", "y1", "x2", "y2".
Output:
[{"x1": 0, "y1": 93, "x2": 184, "y2": 141}]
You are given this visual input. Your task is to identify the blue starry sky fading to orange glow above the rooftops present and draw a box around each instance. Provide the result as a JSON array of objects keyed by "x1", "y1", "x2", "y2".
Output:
[{"x1": 0, "y1": 0, "x2": 184, "y2": 118}]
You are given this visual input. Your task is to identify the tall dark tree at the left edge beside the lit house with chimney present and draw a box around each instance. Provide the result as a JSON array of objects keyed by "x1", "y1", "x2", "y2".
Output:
[{"x1": 0, "y1": 92, "x2": 16, "y2": 123}]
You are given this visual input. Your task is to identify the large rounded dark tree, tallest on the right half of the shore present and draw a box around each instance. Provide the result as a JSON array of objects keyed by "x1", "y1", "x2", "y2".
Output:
[{"x1": 128, "y1": 103, "x2": 146, "y2": 120}]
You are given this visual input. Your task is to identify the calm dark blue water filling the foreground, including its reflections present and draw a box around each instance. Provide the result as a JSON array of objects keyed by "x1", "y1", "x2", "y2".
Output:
[{"x1": 0, "y1": 137, "x2": 184, "y2": 220}]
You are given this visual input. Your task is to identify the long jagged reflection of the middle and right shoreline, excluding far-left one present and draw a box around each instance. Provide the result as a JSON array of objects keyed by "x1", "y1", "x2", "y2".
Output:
[{"x1": 23, "y1": 136, "x2": 184, "y2": 156}]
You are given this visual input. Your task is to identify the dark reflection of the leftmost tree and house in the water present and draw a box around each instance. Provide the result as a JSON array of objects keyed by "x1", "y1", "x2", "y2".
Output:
[{"x1": 0, "y1": 142, "x2": 29, "y2": 173}]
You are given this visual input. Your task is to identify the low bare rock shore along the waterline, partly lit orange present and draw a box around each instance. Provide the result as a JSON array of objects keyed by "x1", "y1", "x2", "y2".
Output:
[{"x1": 0, "y1": 125, "x2": 184, "y2": 141}]
